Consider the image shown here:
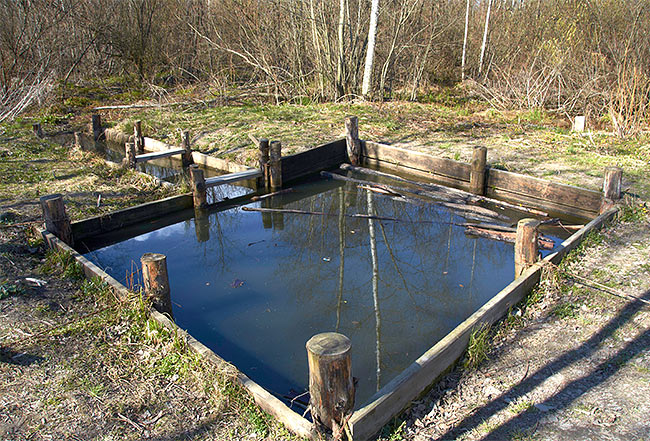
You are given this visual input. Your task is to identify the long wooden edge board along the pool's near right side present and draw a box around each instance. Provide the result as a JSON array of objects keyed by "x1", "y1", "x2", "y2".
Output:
[{"x1": 348, "y1": 208, "x2": 618, "y2": 441}]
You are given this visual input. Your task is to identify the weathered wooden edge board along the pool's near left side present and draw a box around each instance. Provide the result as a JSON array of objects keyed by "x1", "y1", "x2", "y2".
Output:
[{"x1": 37, "y1": 228, "x2": 313, "y2": 438}]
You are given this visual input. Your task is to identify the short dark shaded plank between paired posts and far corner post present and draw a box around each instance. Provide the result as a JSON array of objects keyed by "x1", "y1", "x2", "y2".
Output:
[{"x1": 282, "y1": 139, "x2": 348, "y2": 185}]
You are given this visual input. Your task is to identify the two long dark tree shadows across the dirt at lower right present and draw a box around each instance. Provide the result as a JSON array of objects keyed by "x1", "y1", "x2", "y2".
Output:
[{"x1": 436, "y1": 290, "x2": 650, "y2": 440}]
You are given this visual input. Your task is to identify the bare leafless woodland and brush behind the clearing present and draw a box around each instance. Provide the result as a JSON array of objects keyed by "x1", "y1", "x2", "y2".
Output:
[{"x1": 0, "y1": 0, "x2": 650, "y2": 136}]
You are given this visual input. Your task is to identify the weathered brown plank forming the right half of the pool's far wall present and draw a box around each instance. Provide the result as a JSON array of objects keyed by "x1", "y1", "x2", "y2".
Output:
[{"x1": 486, "y1": 168, "x2": 602, "y2": 218}]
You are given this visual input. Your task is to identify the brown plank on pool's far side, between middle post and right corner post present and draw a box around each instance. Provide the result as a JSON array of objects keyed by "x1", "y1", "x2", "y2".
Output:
[{"x1": 487, "y1": 168, "x2": 603, "y2": 214}]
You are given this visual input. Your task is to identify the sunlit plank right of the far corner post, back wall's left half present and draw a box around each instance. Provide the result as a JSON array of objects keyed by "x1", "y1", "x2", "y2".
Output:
[{"x1": 361, "y1": 141, "x2": 470, "y2": 182}]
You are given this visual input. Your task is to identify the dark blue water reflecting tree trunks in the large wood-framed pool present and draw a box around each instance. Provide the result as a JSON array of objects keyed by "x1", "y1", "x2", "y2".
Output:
[{"x1": 86, "y1": 172, "x2": 559, "y2": 408}]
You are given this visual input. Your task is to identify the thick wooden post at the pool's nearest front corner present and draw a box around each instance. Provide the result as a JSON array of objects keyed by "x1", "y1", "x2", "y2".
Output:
[{"x1": 306, "y1": 332, "x2": 354, "y2": 433}]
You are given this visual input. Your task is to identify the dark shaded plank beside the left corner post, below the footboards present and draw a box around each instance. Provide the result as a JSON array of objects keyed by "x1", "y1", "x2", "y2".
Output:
[{"x1": 71, "y1": 193, "x2": 194, "y2": 241}]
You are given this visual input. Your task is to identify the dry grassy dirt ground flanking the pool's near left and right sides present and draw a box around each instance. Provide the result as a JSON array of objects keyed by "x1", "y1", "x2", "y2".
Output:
[{"x1": 0, "y1": 107, "x2": 650, "y2": 441}]
